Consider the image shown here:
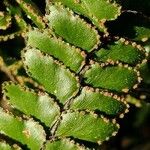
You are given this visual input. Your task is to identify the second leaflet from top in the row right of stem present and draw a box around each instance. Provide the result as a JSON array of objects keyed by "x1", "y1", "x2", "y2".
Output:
[{"x1": 84, "y1": 63, "x2": 138, "y2": 92}]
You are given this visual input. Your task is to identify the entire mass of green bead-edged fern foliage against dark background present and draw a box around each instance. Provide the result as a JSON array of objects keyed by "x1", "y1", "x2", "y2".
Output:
[{"x1": 0, "y1": 0, "x2": 149, "y2": 150}]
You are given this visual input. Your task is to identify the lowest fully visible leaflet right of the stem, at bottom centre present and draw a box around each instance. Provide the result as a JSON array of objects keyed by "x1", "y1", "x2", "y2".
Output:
[{"x1": 56, "y1": 112, "x2": 118, "y2": 143}]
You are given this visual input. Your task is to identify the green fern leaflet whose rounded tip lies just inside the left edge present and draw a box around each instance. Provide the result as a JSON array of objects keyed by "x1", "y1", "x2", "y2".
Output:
[{"x1": 3, "y1": 82, "x2": 60, "y2": 127}]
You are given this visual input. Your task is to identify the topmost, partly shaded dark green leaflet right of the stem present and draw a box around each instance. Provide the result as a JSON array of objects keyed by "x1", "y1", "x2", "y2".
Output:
[{"x1": 95, "y1": 39, "x2": 145, "y2": 65}]
